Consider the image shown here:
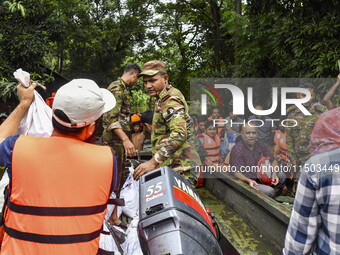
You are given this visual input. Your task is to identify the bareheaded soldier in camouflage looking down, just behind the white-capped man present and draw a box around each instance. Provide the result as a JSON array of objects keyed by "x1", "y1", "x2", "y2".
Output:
[{"x1": 102, "y1": 63, "x2": 141, "y2": 227}]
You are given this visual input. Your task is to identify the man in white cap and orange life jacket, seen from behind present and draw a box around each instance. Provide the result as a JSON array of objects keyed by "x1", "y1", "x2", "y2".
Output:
[{"x1": 0, "y1": 79, "x2": 116, "y2": 255}]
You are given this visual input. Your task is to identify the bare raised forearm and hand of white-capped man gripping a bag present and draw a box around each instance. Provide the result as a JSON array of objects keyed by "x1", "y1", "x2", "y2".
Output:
[{"x1": 0, "y1": 82, "x2": 36, "y2": 143}]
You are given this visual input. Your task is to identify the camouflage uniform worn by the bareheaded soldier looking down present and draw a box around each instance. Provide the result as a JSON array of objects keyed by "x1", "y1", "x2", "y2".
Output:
[{"x1": 102, "y1": 79, "x2": 131, "y2": 191}]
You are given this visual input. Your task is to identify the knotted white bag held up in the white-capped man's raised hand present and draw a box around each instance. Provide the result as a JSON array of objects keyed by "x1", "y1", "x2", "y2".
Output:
[{"x1": 13, "y1": 68, "x2": 53, "y2": 137}]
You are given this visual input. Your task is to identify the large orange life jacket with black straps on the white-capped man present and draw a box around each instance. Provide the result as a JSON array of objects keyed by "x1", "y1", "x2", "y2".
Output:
[{"x1": 1, "y1": 136, "x2": 113, "y2": 255}]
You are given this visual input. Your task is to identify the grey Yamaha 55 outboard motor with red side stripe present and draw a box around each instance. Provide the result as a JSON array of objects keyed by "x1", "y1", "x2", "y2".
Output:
[{"x1": 138, "y1": 167, "x2": 222, "y2": 255}]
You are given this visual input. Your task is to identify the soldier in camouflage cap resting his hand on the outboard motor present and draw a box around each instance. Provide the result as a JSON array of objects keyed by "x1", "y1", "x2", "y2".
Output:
[{"x1": 134, "y1": 60, "x2": 201, "y2": 179}]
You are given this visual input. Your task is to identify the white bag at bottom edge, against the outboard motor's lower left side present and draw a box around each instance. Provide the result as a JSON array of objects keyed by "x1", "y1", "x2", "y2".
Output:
[{"x1": 122, "y1": 217, "x2": 143, "y2": 255}]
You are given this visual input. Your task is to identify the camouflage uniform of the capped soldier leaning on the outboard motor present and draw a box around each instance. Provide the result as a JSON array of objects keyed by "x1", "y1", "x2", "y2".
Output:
[{"x1": 151, "y1": 85, "x2": 201, "y2": 173}]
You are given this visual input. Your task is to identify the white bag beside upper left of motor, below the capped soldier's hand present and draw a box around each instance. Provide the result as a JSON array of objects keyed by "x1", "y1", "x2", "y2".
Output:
[{"x1": 120, "y1": 167, "x2": 139, "y2": 218}]
